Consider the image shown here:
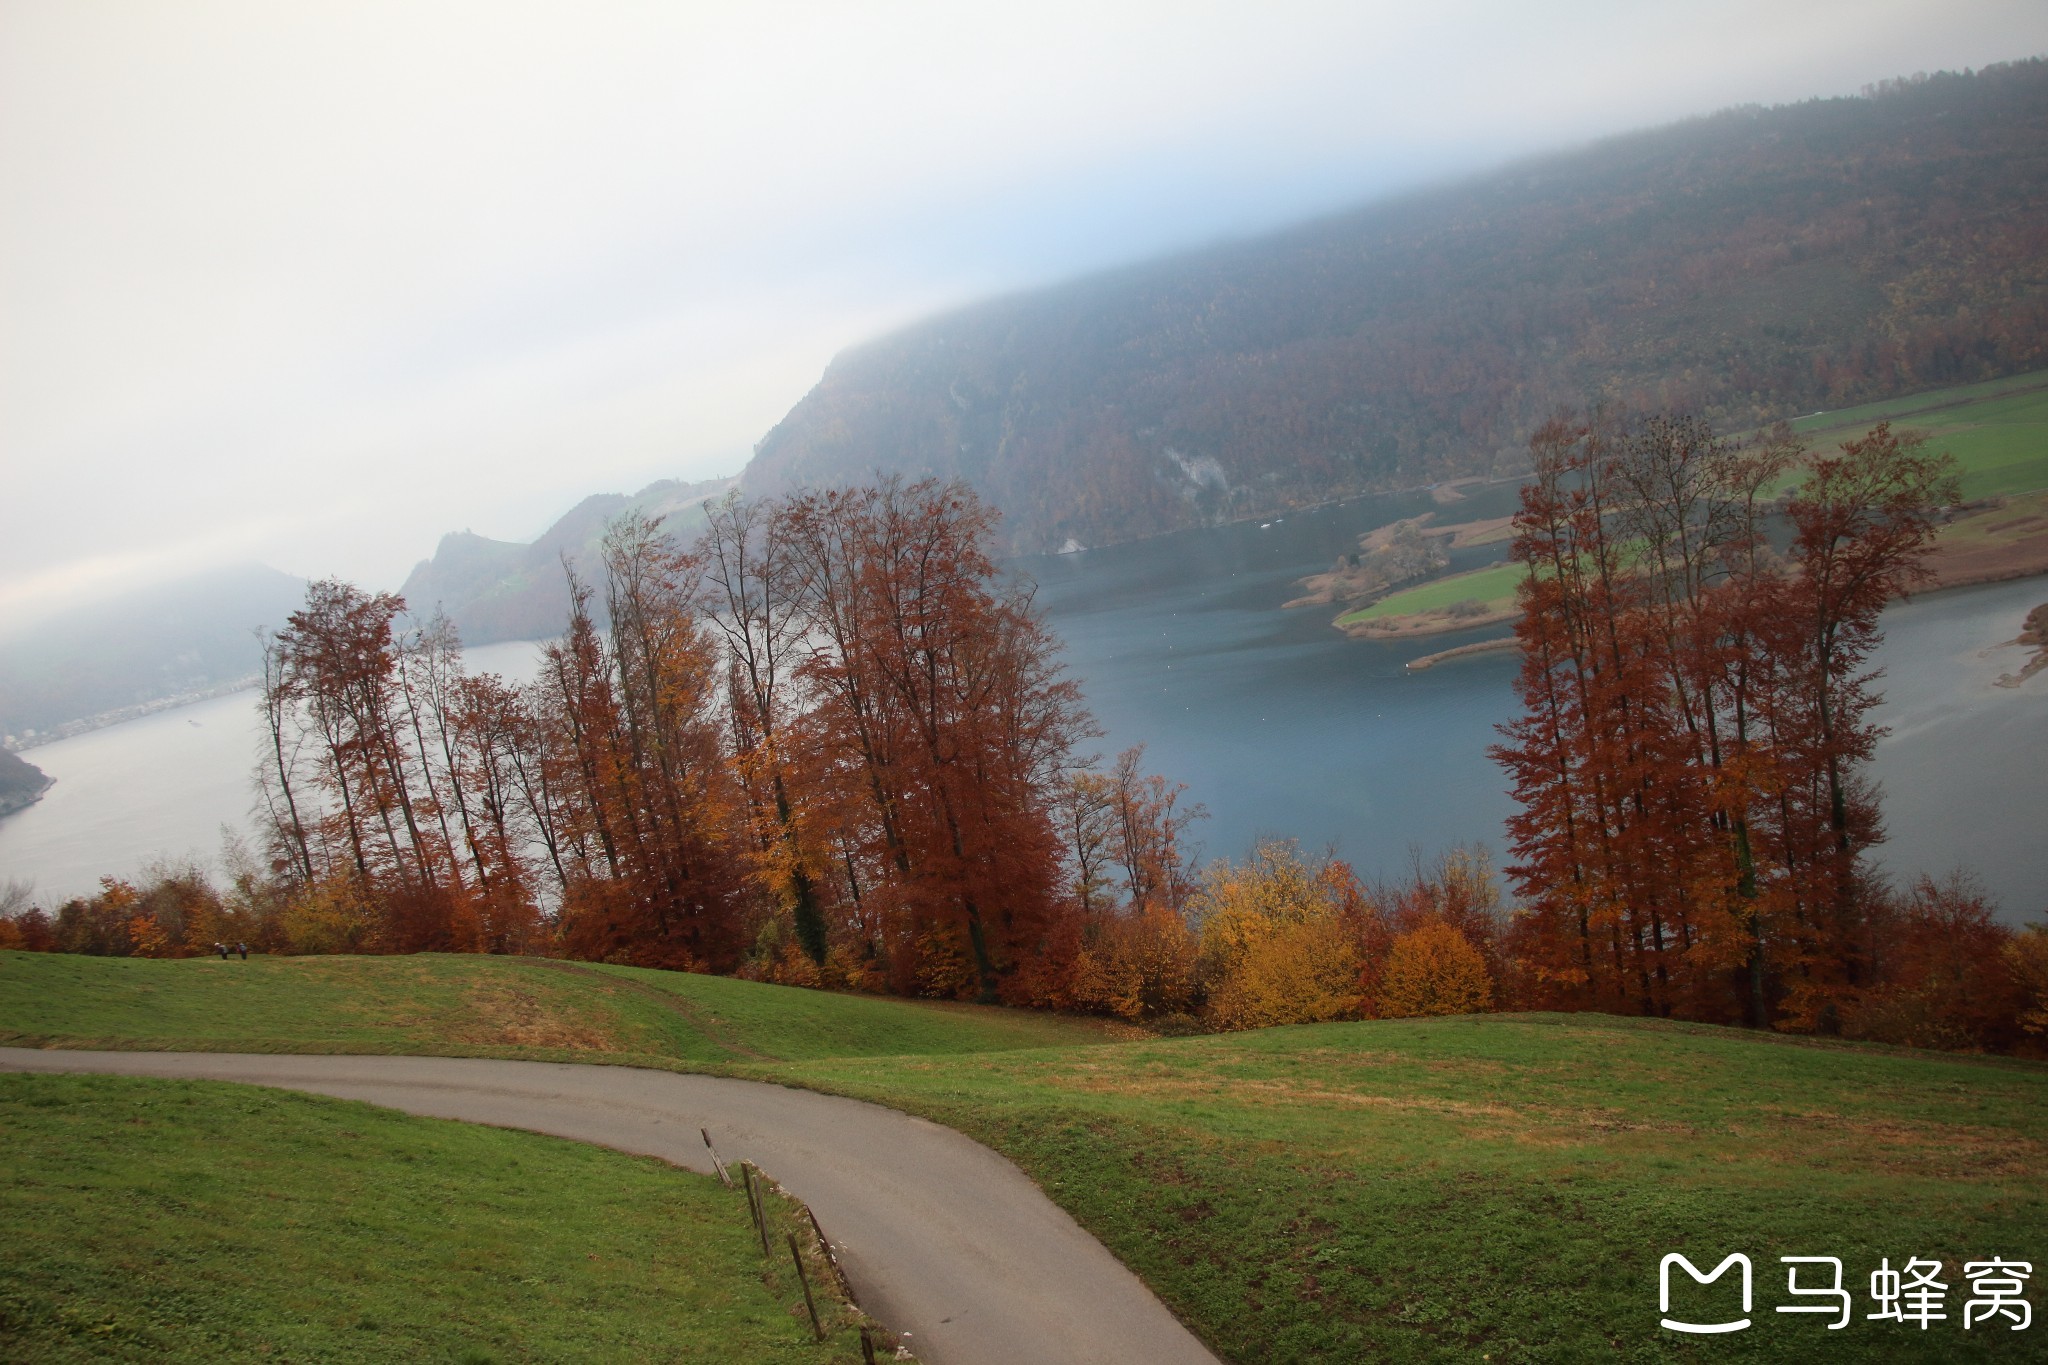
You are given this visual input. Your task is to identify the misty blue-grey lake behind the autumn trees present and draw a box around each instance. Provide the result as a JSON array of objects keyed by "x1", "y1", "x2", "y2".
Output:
[{"x1": 0, "y1": 501, "x2": 2048, "y2": 921}]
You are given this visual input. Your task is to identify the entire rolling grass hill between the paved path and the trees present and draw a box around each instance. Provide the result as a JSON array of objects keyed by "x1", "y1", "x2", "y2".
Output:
[{"x1": 0, "y1": 954, "x2": 2048, "y2": 1361}]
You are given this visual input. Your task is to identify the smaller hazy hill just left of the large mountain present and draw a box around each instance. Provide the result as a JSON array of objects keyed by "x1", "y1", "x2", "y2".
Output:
[{"x1": 399, "y1": 479, "x2": 733, "y2": 645}]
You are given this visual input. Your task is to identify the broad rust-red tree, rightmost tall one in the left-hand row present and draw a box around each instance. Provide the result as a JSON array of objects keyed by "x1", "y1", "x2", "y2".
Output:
[{"x1": 778, "y1": 479, "x2": 1092, "y2": 999}]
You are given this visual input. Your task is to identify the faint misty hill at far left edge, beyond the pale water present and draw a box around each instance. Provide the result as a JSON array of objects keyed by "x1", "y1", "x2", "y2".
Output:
[{"x1": 0, "y1": 565, "x2": 305, "y2": 737}]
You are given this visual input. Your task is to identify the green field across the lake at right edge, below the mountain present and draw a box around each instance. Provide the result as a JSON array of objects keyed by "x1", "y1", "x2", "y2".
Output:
[{"x1": 1792, "y1": 370, "x2": 2048, "y2": 499}]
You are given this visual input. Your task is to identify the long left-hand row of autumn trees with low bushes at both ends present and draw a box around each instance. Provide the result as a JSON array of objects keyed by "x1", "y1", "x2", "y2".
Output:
[{"x1": 4, "y1": 481, "x2": 1540, "y2": 1027}]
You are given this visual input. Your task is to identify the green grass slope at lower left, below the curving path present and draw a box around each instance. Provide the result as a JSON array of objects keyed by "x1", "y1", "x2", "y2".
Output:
[{"x1": 0, "y1": 1074, "x2": 860, "y2": 1365}]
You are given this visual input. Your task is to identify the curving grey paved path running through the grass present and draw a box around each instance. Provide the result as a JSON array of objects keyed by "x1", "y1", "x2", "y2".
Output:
[{"x1": 0, "y1": 1048, "x2": 1214, "y2": 1365}]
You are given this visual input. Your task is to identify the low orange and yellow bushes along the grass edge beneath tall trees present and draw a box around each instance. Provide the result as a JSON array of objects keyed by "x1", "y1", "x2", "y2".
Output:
[{"x1": 12, "y1": 826, "x2": 2048, "y2": 1054}]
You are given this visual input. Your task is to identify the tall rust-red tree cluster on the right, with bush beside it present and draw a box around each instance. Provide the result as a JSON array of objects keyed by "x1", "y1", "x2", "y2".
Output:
[{"x1": 1495, "y1": 411, "x2": 2048, "y2": 1042}]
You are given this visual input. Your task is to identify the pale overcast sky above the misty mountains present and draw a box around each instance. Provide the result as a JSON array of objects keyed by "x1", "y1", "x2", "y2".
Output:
[{"x1": 0, "y1": 0, "x2": 2048, "y2": 632}]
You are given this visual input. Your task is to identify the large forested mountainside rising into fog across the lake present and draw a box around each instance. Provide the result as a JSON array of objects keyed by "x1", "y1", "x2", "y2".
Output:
[{"x1": 741, "y1": 59, "x2": 2048, "y2": 551}]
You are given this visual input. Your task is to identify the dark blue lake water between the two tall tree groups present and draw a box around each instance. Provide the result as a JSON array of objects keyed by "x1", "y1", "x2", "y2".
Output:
[{"x1": 1020, "y1": 487, "x2": 1516, "y2": 874}]
